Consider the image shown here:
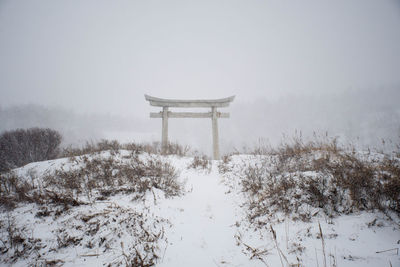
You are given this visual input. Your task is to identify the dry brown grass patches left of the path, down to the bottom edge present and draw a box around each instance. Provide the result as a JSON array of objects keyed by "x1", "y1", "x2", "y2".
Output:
[{"x1": 0, "y1": 150, "x2": 182, "y2": 266}]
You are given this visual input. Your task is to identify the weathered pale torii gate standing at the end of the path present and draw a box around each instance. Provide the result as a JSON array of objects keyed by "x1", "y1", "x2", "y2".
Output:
[{"x1": 144, "y1": 95, "x2": 235, "y2": 159}]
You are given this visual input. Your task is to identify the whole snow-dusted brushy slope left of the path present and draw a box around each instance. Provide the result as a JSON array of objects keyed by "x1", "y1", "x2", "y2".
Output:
[{"x1": 0, "y1": 150, "x2": 183, "y2": 266}]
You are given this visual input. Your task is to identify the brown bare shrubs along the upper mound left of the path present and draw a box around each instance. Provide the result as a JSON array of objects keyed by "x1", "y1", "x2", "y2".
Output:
[{"x1": 0, "y1": 154, "x2": 182, "y2": 214}]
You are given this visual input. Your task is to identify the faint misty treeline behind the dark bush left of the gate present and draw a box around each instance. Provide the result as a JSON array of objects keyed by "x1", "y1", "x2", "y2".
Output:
[{"x1": 0, "y1": 104, "x2": 146, "y2": 146}]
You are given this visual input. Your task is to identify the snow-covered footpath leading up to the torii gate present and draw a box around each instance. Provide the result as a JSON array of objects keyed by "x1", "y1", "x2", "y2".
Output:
[{"x1": 153, "y1": 161, "x2": 256, "y2": 267}]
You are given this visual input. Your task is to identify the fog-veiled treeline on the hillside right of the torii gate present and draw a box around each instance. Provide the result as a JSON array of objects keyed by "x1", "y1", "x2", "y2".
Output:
[{"x1": 227, "y1": 88, "x2": 400, "y2": 150}]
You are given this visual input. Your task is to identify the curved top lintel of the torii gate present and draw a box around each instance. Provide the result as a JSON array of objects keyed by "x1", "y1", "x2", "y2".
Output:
[{"x1": 144, "y1": 95, "x2": 235, "y2": 108}]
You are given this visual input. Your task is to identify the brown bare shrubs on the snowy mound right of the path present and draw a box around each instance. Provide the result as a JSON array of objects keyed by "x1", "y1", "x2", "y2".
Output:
[{"x1": 233, "y1": 136, "x2": 400, "y2": 226}]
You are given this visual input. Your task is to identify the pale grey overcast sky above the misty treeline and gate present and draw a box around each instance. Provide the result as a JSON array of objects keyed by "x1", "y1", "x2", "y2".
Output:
[{"x1": 0, "y1": 0, "x2": 400, "y2": 154}]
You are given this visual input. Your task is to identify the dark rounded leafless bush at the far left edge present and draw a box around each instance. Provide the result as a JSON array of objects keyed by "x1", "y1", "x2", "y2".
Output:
[{"x1": 0, "y1": 128, "x2": 62, "y2": 171}]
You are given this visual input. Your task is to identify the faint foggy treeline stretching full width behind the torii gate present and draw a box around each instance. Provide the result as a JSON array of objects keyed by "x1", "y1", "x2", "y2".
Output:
[{"x1": 0, "y1": 87, "x2": 400, "y2": 156}]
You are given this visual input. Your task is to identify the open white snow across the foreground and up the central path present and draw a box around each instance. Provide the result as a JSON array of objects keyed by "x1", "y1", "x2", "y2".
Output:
[{"x1": 0, "y1": 156, "x2": 400, "y2": 267}]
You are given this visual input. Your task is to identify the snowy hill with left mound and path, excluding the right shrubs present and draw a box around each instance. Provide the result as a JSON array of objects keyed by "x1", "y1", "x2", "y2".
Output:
[{"x1": 0, "y1": 151, "x2": 400, "y2": 267}]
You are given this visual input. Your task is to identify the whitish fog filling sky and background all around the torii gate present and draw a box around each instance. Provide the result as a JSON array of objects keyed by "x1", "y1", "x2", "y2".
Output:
[{"x1": 0, "y1": 0, "x2": 400, "y2": 153}]
